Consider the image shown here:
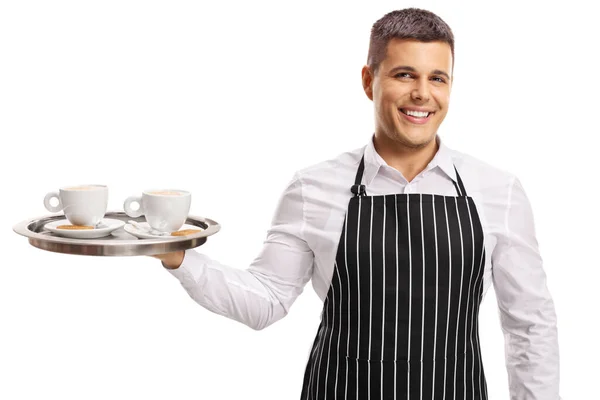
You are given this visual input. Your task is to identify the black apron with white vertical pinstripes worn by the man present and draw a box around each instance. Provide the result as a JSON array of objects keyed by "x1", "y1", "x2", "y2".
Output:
[{"x1": 301, "y1": 156, "x2": 487, "y2": 400}]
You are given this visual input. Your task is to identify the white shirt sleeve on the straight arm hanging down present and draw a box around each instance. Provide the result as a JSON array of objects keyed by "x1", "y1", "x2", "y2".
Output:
[{"x1": 492, "y1": 177, "x2": 560, "y2": 400}]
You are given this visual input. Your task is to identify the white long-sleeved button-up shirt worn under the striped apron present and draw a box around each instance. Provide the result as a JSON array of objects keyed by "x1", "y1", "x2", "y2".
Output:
[{"x1": 169, "y1": 137, "x2": 559, "y2": 400}]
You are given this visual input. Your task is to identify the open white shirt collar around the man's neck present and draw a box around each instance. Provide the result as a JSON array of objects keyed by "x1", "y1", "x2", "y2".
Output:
[{"x1": 363, "y1": 135, "x2": 457, "y2": 186}]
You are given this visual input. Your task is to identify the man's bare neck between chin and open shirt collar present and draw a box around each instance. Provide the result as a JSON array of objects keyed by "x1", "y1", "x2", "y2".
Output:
[{"x1": 373, "y1": 133, "x2": 439, "y2": 182}]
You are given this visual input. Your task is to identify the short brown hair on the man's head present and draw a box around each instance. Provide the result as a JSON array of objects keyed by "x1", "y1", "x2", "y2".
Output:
[{"x1": 367, "y1": 8, "x2": 454, "y2": 73}]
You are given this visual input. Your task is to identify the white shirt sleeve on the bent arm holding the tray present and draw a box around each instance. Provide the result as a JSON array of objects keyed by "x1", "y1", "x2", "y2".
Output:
[{"x1": 168, "y1": 174, "x2": 314, "y2": 330}]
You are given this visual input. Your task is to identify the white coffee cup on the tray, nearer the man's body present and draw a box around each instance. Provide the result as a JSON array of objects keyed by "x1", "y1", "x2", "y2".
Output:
[{"x1": 123, "y1": 189, "x2": 192, "y2": 232}]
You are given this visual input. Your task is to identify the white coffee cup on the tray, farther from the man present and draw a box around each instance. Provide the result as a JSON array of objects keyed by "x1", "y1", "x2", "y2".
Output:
[{"x1": 44, "y1": 185, "x2": 108, "y2": 226}]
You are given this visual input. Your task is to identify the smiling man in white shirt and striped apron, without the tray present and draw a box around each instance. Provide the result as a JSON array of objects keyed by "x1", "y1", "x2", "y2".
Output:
[{"x1": 156, "y1": 8, "x2": 559, "y2": 400}]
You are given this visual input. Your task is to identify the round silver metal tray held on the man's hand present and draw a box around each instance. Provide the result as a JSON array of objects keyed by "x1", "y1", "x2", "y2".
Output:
[{"x1": 13, "y1": 212, "x2": 221, "y2": 256}]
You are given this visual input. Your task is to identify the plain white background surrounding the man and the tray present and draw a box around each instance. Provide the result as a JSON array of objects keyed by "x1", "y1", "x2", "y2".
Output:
[{"x1": 0, "y1": 0, "x2": 600, "y2": 400}]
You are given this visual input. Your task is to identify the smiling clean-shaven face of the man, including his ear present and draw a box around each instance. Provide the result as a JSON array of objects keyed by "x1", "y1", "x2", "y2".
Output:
[{"x1": 362, "y1": 39, "x2": 452, "y2": 148}]
